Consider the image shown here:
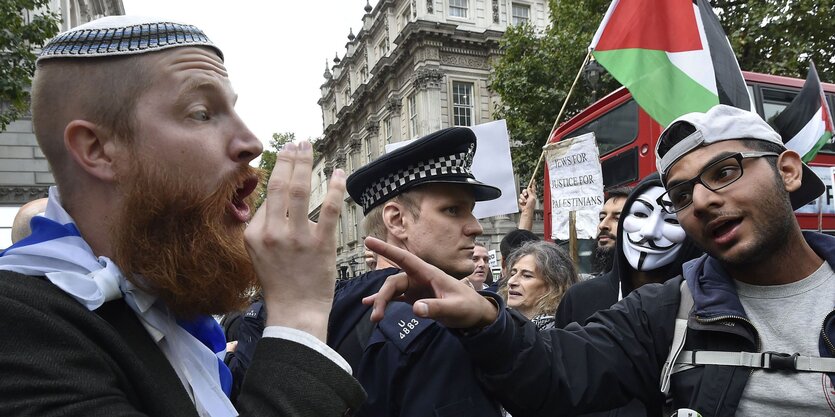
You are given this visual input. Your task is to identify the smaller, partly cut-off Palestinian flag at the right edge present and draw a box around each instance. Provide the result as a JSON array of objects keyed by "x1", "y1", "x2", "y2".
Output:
[{"x1": 773, "y1": 62, "x2": 835, "y2": 162}]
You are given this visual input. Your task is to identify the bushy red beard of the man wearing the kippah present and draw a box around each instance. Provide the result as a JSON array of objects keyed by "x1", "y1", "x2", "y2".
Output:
[{"x1": 112, "y1": 157, "x2": 260, "y2": 319}]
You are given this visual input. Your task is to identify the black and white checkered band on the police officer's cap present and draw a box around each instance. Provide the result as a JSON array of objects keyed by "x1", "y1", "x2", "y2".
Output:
[{"x1": 360, "y1": 146, "x2": 474, "y2": 211}]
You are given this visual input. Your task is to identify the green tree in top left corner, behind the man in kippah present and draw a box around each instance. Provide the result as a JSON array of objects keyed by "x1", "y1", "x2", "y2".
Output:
[{"x1": 0, "y1": 0, "x2": 61, "y2": 132}]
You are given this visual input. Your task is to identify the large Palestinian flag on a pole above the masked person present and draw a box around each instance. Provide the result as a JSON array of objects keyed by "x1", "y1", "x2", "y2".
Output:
[{"x1": 590, "y1": 0, "x2": 751, "y2": 127}]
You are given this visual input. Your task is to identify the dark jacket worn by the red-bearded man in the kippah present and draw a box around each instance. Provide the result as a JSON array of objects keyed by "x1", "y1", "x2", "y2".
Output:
[{"x1": 0, "y1": 271, "x2": 364, "y2": 417}]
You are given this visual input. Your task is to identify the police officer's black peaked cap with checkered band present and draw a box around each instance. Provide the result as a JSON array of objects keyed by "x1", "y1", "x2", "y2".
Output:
[{"x1": 347, "y1": 127, "x2": 501, "y2": 214}]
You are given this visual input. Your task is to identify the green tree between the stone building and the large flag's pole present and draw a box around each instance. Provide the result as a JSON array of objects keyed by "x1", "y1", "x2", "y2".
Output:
[{"x1": 490, "y1": 0, "x2": 618, "y2": 190}]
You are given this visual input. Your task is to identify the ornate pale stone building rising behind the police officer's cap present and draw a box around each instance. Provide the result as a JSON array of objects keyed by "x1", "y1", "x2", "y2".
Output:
[{"x1": 311, "y1": 0, "x2": 549, "y2": 276}]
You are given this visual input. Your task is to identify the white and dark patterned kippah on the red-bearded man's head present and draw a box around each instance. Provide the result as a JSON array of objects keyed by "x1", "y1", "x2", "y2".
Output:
[{"x1": 38, "y1": 16, "x2": 223, "y2": 62}]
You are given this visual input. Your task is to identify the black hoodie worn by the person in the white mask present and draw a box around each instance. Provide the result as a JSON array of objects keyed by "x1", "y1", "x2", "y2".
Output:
[{"x1": 556, "y1": 173, "x2": 702, "y2": 417}]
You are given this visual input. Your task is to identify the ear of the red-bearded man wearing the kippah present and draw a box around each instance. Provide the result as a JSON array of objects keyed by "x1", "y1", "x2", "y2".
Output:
[{"x1": 64, "y1": 120, "x2": 117, "y2": 181}]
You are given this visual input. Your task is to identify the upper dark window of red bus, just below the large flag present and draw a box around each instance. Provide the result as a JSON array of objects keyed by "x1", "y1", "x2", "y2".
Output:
[{"x1": 566, "y1": 100, "x2": 638, "y2": 156}]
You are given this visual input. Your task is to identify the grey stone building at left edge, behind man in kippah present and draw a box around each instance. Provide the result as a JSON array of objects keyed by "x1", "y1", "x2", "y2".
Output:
[{"x1": 0, "y1": 0, "x2": 125, "y2": 249}]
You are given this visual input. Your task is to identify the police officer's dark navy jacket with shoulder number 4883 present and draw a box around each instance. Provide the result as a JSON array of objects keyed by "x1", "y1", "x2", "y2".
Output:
[{"x1": 328, "y1": 268, "x2": 501, "y2": 417}]
